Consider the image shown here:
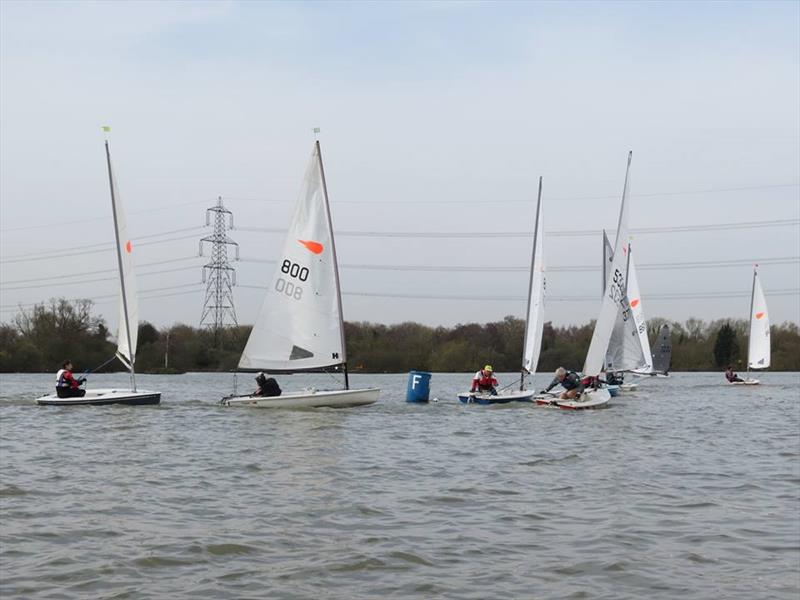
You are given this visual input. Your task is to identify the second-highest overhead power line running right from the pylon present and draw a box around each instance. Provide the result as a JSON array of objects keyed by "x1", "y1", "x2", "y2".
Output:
[{"x1": 237, "y1": 219, "x2": 800, "y2": 239}]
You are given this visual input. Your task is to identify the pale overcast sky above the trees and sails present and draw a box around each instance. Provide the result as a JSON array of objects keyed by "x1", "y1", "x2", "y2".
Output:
[{"x1": 0, "y1": 0, "x2": 800, "y2": 326}]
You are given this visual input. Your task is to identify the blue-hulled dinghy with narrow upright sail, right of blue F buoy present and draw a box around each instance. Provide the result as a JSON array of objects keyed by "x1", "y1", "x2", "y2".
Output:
[{"x1": 458, "y1": 177, "x2": 545, "y2": 404}]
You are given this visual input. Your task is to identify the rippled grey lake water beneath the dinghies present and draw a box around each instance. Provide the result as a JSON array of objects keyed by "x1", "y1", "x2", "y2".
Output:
[{"x1": 0, "y1": 373, "x2": 800, "y2": 600}]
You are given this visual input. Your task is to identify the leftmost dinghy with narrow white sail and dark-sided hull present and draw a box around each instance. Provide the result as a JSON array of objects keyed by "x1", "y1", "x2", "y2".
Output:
[{"x1": 36, "y1": 134, "x2": 161, "y2": 406}]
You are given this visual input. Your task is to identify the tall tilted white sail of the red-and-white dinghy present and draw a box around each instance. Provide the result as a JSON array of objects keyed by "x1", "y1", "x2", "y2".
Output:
[{"x1": 583, "y1": 152, "x2": 642, "y2": 376}]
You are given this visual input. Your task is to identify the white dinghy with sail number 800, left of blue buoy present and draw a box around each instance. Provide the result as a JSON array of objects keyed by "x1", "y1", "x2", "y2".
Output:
[{"x1": 221, "y1": 141, "x2": 380, "y2": 408}]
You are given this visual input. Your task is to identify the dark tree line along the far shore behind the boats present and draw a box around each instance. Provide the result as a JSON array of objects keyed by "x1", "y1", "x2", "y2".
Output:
[{"x1": 0, "y1": 298, "x2": 800, "y2": 373}]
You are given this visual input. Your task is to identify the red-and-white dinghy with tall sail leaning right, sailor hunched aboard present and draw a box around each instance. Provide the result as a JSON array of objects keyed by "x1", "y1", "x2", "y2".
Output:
[{"x1": 537, "y1": 152, "x2": 641, "y2": 409}]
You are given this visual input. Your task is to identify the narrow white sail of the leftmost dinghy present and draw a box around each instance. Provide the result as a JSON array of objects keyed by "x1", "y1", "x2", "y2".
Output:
[{"x1": 106, "y1": 140, "x2": 139, "y2": 371}]
